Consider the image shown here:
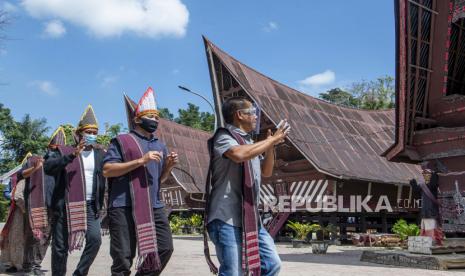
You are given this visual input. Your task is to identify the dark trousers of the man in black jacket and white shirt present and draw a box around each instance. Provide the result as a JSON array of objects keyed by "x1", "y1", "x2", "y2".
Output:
[{"x1": 52, "y1": 201, "x2": 102, "y2": 276}]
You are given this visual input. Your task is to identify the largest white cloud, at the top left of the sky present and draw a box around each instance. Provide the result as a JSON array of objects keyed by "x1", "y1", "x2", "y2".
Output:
[{"x1": 21, "y1": 0, "x2": 189, "y2": 38}]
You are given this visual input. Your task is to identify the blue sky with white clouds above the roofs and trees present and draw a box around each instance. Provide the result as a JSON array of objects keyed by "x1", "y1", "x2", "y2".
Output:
[{"x1": 0, "y1": 0, "x2": 395, "y2": 134}]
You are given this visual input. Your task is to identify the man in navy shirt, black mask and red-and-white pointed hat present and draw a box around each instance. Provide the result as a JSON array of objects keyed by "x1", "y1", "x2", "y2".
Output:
[{"x1": 103, "y1": 87, "x2": 178, "y2": 275}]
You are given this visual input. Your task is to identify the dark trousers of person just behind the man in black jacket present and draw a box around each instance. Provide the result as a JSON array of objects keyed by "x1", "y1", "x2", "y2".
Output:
[{"x1": 23, "y1": 210, "x2": 51, "y2": 271}]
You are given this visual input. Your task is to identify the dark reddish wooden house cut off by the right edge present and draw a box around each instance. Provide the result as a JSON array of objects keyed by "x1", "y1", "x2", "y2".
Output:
[{"x1": 385, "y1": 0, "x2": 465, "y2": 234}]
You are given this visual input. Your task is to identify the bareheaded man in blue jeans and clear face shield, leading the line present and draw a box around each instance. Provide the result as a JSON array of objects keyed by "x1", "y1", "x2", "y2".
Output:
[{"x1": 204, "y1": 97, "x2": 290, "y2": 276}]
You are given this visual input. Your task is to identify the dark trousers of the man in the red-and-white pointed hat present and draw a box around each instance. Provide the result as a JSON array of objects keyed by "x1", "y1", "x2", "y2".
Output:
[{"x1": 108, "y1": 207, "x2": 173, "y2": 276}]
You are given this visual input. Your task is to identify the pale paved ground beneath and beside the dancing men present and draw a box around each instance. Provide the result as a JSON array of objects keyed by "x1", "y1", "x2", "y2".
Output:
[{"x1": 0, "y1": 236, "x2": 465, "y2": 276}]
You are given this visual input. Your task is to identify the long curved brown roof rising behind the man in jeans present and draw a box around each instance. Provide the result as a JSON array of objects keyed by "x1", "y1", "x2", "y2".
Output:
[{"x1": 205, "y1": 36, "x2": 421, "y2": 184}]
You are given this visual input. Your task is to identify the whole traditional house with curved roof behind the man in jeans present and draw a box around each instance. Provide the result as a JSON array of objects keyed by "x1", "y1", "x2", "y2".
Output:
[{"x1": 204, "y1": 39, "x2": 421, "y2": 239}]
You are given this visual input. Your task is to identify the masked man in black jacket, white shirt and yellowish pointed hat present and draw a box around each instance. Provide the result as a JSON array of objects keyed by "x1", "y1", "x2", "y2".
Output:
[{"x1": 44, "y1": 105, "x2": 105, "y2": 276}]
